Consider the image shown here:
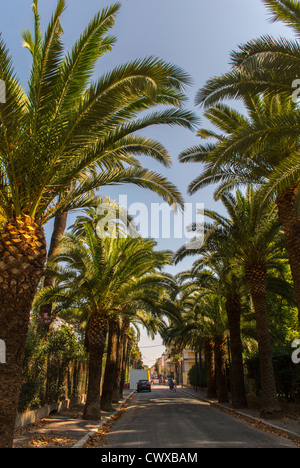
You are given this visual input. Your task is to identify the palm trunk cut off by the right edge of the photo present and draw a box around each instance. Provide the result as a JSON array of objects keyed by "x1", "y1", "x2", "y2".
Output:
[{"x1": 276, "y1": 187, "x2": 300, "y2": 322}]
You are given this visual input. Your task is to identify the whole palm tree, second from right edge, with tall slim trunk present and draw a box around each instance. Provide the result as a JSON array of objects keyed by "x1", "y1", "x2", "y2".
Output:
[{"x1": 206, "y1": 187, "x2": 285, "y2": 417}]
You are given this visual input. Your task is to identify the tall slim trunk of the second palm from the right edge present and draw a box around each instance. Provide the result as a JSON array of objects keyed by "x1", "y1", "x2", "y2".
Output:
[{"x1": 246, "y1": 265, "x2": 280, "y2": 418}]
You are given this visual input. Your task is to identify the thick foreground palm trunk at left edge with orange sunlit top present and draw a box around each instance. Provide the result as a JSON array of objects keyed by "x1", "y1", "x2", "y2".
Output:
[{"x1": 0, "y1": 215, "x2": 46, "y2": 447}]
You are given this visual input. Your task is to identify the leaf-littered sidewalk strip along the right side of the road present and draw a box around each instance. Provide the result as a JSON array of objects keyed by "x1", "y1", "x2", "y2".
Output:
[{"x1": 178, "y1": 387, "x2": 300, "y2": 443}]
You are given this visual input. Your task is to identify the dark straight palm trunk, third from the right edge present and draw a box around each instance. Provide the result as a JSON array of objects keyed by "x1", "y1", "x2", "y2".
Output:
[{"x1": 225, "y1": 297, "x2": 248, "y2": 408}]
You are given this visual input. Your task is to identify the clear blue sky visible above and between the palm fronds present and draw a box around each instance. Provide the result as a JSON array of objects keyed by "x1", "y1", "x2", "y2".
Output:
[{"x1": 0, "y1": 0, "x2": 291, "y2": 365}]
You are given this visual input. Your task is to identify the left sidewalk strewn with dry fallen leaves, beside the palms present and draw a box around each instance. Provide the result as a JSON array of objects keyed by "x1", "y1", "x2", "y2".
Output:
[{"x1": 14, "y1": 389, "x2": 134, "y2": 448}]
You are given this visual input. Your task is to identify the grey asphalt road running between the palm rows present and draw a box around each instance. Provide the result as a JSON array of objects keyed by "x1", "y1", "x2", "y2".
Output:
[{"x1": 106, "y1": 385, "x2": 296, "y2": 449}]
